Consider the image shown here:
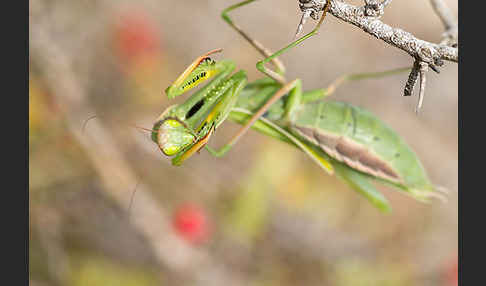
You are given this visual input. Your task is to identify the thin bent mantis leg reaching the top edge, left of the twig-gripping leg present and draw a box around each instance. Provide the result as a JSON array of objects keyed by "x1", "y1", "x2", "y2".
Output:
[{"x1": 221, "y1": 0, "x2": 285, "y2": 76}]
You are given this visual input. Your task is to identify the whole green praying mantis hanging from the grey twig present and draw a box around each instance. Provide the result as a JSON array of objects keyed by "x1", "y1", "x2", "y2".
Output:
[{"x1": 147, "y1": 0, "x2": 441, "y2": 211}]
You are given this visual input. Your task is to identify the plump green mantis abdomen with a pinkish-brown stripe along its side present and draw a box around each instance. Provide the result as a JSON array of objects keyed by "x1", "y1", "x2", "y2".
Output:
[{"x1": 290, "y1": 101, "x2": 434, "y2": 197}]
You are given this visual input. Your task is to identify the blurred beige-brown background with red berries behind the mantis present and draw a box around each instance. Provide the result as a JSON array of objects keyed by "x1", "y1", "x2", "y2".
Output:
[{"x1": 29, "y1": 0, "x2": 458, "y2": 286}]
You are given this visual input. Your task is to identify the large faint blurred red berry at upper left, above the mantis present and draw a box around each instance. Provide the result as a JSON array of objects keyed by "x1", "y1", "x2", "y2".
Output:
[{"x1": 115, "y1": 12, "x2": 160, "y2": 62}]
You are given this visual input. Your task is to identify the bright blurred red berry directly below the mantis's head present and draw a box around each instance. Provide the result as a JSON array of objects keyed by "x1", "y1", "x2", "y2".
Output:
[{"x1": 172, "y1": 204, "x2": 209, "y2": 244}]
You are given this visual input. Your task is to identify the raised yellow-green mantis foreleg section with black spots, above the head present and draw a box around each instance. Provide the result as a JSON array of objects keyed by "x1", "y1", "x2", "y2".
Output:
[{"x1": 165, "y1": 49, "x2": 222, "y2": 99}]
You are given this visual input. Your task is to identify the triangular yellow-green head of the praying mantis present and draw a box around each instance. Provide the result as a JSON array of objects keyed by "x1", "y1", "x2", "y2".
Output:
[{"x1": 157, "y1": 118, "x2": 195, "y2": 156}]
